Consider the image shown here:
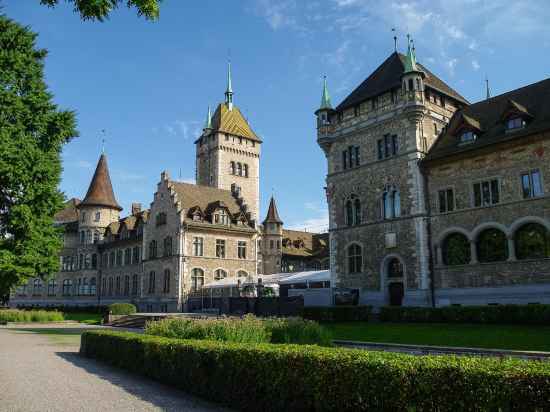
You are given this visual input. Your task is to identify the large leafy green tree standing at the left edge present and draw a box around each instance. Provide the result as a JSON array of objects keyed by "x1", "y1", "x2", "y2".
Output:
[{"x1": 0, "y1": 15, "x2": 78, "y2": 296}]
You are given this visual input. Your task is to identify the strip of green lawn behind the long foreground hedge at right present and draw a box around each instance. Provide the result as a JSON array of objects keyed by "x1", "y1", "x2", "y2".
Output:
[{"x1": 324, "y1": 322, "x2": 550, "y2": 352}]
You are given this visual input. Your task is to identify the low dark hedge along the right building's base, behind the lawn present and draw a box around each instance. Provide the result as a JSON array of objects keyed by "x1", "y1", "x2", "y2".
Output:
[{"x1": 380, "y1": 305, "x2": 550, "y2": 325}]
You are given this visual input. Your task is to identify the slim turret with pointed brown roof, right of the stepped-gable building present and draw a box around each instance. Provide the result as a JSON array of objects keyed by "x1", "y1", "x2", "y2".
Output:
[{"x1": 262, "y1": 197, "x2": 283, "y2": 275}]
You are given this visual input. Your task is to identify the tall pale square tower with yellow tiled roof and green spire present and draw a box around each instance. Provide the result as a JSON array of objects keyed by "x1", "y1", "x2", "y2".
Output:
[{"x1": 195, "y1": 65, "x2": 262, "y2": 221}]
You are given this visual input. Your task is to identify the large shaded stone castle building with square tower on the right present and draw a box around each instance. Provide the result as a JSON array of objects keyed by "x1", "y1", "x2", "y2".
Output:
[{"x1": 316, "y1": 38, "x2": 550, "y2": 306}]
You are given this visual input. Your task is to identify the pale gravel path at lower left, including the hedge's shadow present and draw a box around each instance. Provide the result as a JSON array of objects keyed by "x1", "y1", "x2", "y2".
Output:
[{"x1": 0, "y1": 325, "x2": 232, "y2": 412}]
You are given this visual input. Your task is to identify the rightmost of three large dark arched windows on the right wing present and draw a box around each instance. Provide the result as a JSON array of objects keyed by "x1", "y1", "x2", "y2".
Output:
[{"x1": 514, "y1": 223, "x2": 550, "y2": 259}]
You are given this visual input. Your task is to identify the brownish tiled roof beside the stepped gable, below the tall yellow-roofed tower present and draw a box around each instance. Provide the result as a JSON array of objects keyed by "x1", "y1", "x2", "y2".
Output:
[{"x1": 170, "y1": 182, "x2": 241, "y2": 215}]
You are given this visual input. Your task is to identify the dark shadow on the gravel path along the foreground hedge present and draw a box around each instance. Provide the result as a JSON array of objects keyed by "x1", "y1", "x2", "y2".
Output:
[{"x1": 55, "y1": 352, "x2": 230, "y2": 412}]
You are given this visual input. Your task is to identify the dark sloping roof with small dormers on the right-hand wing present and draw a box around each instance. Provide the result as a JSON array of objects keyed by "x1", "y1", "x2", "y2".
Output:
[{"x1": 424, "y1": 79, "x2": 550, "y2": 163}]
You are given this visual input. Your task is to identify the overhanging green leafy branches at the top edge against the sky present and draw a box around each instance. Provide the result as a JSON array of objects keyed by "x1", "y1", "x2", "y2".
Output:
[{"x1": 40, "y1": 0, "x2": 162, "y2": 21}]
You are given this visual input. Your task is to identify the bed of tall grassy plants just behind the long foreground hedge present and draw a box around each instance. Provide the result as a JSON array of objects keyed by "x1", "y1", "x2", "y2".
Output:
[{"x1": 145, "y1": 315, "x2": 331, "y2": 346}]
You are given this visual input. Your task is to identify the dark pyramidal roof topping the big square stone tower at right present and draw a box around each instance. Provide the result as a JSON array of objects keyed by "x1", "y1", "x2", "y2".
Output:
[{"x1": 336, "y1": 52, "x2": 468, "y2": 111}]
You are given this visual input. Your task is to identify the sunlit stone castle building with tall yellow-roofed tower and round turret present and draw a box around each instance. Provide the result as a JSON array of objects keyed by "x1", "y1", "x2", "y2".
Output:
[{"x1": 10, "y1": 64, "x2": 328, "y2": 312}]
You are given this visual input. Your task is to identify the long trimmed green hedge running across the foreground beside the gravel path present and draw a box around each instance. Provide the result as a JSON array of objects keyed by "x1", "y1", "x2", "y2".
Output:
[{"x1": 80, "y1": 331, "x2": 550, "y2": 412}]
